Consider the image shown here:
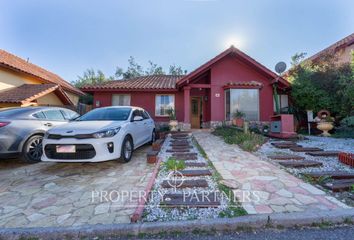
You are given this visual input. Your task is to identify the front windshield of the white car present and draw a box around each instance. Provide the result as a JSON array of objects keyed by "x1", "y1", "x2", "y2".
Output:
[{"x1": 75, "y1": 108, "x2": 131, "y2": 121}]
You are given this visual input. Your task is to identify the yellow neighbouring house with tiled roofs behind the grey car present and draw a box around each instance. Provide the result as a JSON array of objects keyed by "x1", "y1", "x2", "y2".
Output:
[{"x1": 0, "y1": 49, "x2": 84, "y2": 108}]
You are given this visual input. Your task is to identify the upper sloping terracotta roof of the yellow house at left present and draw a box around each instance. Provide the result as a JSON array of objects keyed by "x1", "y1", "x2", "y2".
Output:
[{"x1": 0, "y1": 49, "x2": 84, "y2": 95}]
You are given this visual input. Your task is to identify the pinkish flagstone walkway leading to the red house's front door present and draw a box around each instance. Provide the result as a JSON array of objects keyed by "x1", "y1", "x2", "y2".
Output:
[{"x1": 193, "y1": 131, "x2": 349, "y2": 214}]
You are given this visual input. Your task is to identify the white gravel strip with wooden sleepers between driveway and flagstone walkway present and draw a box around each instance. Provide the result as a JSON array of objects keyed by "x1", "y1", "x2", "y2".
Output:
[{"x1": 142, "y1": 134, "x2": 245, "y2": 222}]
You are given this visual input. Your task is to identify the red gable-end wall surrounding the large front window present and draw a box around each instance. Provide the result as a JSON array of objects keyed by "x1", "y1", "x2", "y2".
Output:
[{"x1": 211, "y1": 56, "x2": 274, "y2": 121}]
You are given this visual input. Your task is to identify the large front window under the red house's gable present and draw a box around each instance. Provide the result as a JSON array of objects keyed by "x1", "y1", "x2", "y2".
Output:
[{"x1": 225, "y1": 89, "x2": 259, "y2": 121}]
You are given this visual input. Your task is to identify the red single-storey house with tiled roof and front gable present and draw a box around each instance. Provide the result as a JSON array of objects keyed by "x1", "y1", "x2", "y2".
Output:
[{"x1": 81, "y1": 46, "x2": 290, "y2": 129}]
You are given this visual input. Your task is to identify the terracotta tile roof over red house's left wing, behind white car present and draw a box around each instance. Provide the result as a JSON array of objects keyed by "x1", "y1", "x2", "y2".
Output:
[{"x1": 81, "y1": 75, "x2": 183, "y2": 91}]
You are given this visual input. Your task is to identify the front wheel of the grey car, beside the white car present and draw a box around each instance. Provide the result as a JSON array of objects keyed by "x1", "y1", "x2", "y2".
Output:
[{"x1": 21, "y1": 135, "x2": 43, "y2": 163}]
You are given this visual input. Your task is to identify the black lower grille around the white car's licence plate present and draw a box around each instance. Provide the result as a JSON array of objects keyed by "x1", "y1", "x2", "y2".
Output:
[{"x1": 44, "y1": 144, "x2": 96, "y2": 159}]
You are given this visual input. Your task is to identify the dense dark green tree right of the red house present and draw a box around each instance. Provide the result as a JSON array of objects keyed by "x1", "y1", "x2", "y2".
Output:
[{"x1": 289, "y1": 53, "x2": 354, "y2": 118}]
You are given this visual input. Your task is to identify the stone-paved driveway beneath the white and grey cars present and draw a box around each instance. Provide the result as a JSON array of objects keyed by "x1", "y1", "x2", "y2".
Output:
[{"x1": 0, "y1": 146, "x2": 154, "y2": 227}]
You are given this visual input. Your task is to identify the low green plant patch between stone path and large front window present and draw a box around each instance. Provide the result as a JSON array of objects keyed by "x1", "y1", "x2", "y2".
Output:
[{"x1": 213, "y1": 127, "x2": 266, "y2": 152}]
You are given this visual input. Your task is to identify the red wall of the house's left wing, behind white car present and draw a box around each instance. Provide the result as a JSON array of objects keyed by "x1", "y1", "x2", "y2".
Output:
[{"x1": 93, "y1": 91, "x2": 184, "y2": 122}]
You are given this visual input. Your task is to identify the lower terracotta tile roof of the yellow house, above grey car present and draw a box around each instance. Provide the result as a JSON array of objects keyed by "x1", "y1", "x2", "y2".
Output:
[{"x1": 0, "y1": 84, "x2": 72, "y2": 104}]
